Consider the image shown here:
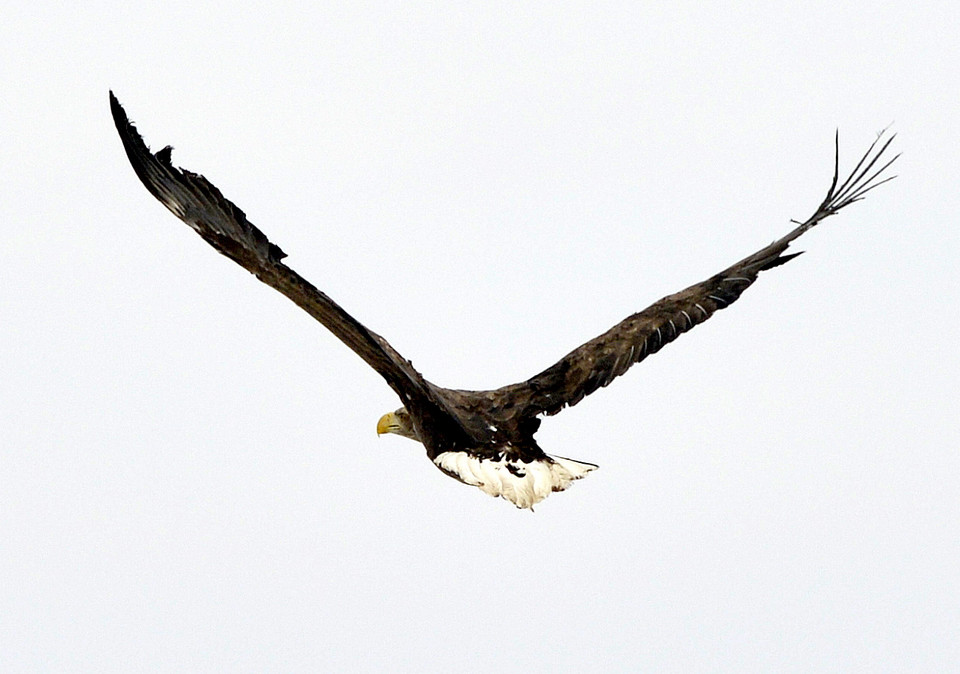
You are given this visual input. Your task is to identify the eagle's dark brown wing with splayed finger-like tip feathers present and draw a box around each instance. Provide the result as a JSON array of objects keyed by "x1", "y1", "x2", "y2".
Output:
[{"x1": 498, "y1": 133, "x2": 899, "y2": 417}]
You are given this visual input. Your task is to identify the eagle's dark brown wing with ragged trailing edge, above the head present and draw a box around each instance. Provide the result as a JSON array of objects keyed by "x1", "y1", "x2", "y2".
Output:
[{"x1": 110, "y1": 92, "x2": 460, "y2": 431}]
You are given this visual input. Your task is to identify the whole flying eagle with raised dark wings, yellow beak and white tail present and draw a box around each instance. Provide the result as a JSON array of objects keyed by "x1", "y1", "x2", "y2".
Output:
[{"x1": 110, "y1": 91, "x2": 899, "y2": 509}]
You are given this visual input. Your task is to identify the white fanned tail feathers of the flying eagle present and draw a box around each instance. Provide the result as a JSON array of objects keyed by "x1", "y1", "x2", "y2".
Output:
[{"x1": 433, "y1": 452, "x2": 597, "y2": 509}]
